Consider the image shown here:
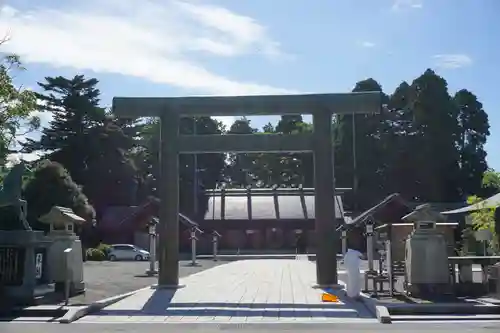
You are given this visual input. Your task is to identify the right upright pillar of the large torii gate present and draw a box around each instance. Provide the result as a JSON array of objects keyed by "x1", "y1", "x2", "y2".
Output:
[{"x1": 313, "y1": 110, "x2": 339, "y2": 287}]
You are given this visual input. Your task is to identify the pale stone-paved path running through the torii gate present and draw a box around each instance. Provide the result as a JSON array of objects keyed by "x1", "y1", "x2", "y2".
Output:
[{"x1": 77, "y1": 258, "x2": 377, "y2": 323}]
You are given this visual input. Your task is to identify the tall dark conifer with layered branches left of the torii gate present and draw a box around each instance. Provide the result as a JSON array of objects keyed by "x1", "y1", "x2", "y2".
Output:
[{"x1": 20, "y1": 75, "x2": 140, "y2": 214}]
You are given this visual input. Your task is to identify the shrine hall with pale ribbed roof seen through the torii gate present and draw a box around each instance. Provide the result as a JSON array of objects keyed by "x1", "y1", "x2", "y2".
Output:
[{"x1": 199, "y1": 188, "x2": 348, "y2": 251}]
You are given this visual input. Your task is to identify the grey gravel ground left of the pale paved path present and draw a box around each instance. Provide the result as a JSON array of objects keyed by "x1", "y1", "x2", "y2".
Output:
[{"x1": 65, "y1": 260, "x2": 226, "y2": 305}]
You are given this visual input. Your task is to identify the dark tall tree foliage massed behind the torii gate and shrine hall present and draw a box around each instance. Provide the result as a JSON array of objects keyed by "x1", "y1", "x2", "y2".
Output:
[{"x1": 7, "y1": 69, "x2": 492, "y2": 228}]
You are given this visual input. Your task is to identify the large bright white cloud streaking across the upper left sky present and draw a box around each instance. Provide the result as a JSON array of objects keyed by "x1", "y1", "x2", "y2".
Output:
[{"x1": 0, "y1": 0, "x2": 296, "y2": 160}]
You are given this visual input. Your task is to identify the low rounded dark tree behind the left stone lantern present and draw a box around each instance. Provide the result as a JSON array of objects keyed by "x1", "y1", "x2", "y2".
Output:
[{"x1": 24, "y1": 160, "x2": 95, "y2": 231}]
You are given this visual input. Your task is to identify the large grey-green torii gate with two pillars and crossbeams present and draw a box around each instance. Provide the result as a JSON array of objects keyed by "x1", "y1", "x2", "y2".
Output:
[{"x1": 113, "y1": 92, "x2": 382, "y2": 288}]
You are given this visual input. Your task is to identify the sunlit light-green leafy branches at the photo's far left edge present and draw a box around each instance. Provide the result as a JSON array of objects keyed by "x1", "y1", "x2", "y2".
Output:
[{"x1": 0, "y1": 46, "x2": 40, "y2": 166}]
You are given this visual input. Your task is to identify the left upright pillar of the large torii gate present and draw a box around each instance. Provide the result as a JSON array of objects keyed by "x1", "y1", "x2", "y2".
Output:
[{"x1": 158, "y1": 113, "x2": 179, "y2": 288}]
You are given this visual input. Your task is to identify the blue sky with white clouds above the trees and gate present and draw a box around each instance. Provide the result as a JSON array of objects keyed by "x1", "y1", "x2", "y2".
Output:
[{"x1": 0, "y1": 0, "x2": 500, "y2": 170}]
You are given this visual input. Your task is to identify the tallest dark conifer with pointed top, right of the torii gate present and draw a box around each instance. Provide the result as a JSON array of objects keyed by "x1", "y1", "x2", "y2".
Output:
[{"x1": 411, "y1": 69, "x2": 461, "y2": 202}]
